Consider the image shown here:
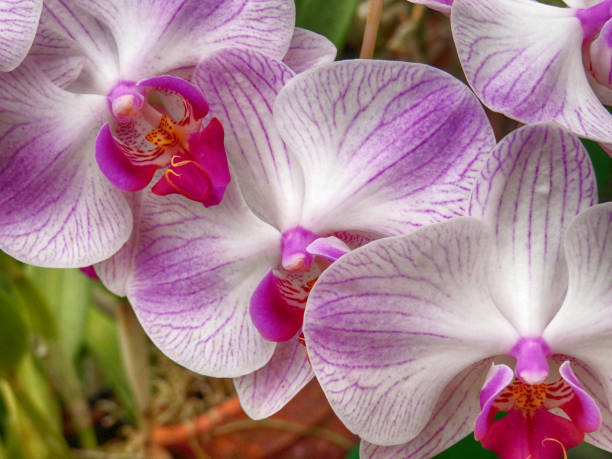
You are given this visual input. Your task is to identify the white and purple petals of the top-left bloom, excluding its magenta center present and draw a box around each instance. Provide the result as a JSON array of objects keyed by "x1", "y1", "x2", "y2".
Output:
[{"x1": 0, "y1": 0, "x2": 294, "y2": 268}]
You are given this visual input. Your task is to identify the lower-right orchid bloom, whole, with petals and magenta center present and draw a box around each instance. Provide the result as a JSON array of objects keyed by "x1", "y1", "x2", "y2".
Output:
[{"x1": 304, "y1": 124, "x2": 612, "y2": 459}]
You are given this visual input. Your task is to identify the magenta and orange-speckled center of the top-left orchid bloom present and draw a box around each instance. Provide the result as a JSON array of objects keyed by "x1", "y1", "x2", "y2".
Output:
[{"x1": 96, "y1": 76, "x2": 230, "y2": 207}]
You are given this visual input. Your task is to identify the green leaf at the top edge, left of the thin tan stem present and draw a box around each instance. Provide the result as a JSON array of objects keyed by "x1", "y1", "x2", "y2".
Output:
[{"x1": 295, "y1": 0, "x2": 360, "y2": 51}]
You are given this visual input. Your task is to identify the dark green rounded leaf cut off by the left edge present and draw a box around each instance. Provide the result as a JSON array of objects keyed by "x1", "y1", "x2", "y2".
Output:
[{"x1": 0, "y1": 290, "x2": 29, "y2": 378}]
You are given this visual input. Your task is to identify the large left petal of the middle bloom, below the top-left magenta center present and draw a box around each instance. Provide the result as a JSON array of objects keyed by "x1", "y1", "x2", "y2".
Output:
[{"x1": 127, "y1": 184, "x2": 280, "y2": 377}]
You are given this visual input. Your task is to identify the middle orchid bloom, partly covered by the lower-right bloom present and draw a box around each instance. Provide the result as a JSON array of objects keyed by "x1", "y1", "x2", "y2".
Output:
[{"x1": 96, "y1": 50, "x2": 494, "y2": 418}]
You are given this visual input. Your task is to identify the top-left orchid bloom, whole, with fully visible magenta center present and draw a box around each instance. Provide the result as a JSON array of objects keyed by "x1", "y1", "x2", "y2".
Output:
[{"x1": 0, "y1": 0, "x2": 294, "y2": 267}]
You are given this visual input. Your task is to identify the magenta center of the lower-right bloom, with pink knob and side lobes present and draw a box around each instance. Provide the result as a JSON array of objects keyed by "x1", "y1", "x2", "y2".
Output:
[{"x1": 474, "y1": 348, "x2": 601, "y2": 459}]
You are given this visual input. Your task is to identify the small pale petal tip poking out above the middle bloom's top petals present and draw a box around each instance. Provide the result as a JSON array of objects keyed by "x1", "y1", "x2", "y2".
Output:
[{"x1": 283, "y1": 27, "x2": 338, "y2": 73}]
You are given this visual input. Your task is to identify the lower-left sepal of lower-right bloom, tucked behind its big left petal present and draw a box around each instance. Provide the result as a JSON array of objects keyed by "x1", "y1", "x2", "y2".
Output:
[{"x1": 359, "y1": 361, "x2": 490, "y2": 459}]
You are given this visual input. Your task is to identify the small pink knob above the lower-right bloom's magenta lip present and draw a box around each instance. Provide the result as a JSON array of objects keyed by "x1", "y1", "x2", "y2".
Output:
[{"x1": 509, "y1": 337, "x2": 550, "y2": 384}]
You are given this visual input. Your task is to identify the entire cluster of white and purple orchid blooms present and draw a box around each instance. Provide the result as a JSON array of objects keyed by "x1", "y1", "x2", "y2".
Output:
[{"x1": 0, "y1": 0, "x2": 612, "y2": 459}]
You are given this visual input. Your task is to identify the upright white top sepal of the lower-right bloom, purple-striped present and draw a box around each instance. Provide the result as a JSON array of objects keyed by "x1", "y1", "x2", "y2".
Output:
[{"x1": 469, "y1": 125, "x2": 597, "y2": 337}]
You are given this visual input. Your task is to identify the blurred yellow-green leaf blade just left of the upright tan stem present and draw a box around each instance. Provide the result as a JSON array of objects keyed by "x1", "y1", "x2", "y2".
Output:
[{"x1": 85, "y1": 308, "x2": 138, "y2": 421}]
